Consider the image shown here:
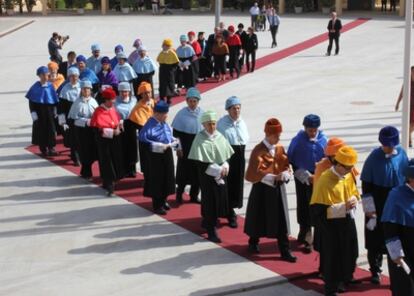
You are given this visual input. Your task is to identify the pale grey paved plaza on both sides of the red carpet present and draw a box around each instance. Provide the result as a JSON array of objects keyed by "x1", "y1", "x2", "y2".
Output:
[{"x1": 0, "y1": 14, "x2": 410, "y2": 296}]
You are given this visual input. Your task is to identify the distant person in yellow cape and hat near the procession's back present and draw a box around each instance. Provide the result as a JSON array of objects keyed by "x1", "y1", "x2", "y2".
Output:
[{"x1": 157, "y1": 39, "x2": 180, "y2": 104}]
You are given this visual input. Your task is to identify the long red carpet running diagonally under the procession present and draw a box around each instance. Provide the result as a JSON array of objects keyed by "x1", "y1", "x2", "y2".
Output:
[{"x1": 27, "y1": 19, "x2": 391, "y2": 296}]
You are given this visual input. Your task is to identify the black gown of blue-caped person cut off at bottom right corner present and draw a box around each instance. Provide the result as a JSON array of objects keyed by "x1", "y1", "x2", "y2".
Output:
[{"x1": 383, "y1": 222, "x2": 414, "y2": 296}]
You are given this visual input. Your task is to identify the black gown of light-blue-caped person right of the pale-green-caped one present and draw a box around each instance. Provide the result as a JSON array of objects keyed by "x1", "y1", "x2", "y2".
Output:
[{"x1": 227, "y1": 145, "x2": 246, "y2": 209}]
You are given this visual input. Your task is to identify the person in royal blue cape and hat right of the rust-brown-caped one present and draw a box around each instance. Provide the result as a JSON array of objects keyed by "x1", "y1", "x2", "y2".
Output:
[{"x1": 287, "y1": 114, "x2": 328, "y2": 253}]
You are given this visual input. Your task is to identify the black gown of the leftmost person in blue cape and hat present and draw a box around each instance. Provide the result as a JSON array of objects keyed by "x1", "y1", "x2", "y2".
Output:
[{"x1": 29, "y1": 101, "x2": 56, "y2": 152}]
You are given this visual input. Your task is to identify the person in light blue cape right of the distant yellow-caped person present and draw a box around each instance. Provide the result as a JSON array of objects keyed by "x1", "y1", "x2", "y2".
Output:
[{"x1": 176, "y1": 35, "x2": 197, "y2": 93}]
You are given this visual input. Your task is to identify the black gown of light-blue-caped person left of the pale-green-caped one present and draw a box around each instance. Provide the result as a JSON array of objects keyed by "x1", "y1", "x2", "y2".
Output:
[{"x1": 173, "y1": 129, "x2": 200, "y2": 199}]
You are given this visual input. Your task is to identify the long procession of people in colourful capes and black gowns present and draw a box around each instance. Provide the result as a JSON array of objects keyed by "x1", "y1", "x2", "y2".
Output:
[{"x1": 26, "y1": 12, "x2": 414, "y2": 296}]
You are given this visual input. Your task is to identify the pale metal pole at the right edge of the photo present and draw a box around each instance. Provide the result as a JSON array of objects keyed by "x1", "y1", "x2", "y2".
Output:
[{"x1": 401, "y1": 0, "x2": 413, "y2": 150}]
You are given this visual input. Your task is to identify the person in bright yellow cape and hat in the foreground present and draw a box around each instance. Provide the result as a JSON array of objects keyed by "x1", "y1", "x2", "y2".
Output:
[{"x1": 310, "y1": 146, "x2": 359, "y2": 295}]
